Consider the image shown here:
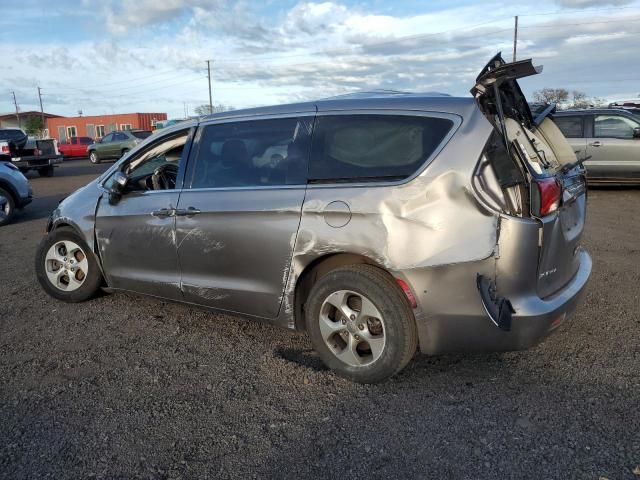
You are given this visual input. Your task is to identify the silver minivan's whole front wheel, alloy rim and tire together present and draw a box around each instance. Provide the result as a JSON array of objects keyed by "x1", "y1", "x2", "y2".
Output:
[{"x1": 35, "y1": 227, "x2": 102, "y2": 303}]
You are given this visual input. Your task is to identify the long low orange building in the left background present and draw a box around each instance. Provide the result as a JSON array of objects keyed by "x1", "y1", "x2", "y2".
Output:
[{"x1": 47, "y1": 113, "x2": 167, "y2": 142}]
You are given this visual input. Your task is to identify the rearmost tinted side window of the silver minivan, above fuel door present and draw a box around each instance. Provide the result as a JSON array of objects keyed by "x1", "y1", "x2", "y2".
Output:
[{"x1": 309, "y1": 115, "x2": 453, "y2": 182}]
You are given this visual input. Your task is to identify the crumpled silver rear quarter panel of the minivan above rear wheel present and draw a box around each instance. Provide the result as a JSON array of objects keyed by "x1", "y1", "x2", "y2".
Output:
[{"x1": 283, "y1": 105, "x2": 499, "y2": 328}]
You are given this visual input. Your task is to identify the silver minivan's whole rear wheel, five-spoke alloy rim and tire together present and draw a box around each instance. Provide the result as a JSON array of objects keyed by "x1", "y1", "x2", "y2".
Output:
[{"x1": 305, "y1": 264, "x2": 418, "y2": 383}]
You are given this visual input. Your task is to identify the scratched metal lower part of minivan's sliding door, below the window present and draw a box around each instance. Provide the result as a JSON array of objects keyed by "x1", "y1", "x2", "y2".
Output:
[{"x1": 176, "y1": 186, "x2": 305, "y2": 318}]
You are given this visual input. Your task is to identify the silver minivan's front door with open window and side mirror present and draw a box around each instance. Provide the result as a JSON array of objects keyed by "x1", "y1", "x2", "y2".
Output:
[{"x1": 96, "y1": 130, "x2": 190, "y2": 299}]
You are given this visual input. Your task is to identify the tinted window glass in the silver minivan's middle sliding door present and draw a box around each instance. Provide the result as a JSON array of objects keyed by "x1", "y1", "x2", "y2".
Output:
[{"x1": 191, "y1": 118, "x2": 312, "y2": 188}]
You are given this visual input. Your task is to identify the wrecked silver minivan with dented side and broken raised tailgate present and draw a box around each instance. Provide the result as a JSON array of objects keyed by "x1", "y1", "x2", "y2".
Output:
[{"x1": 36, "y1": 54, "x2": 591, "y2": 382}]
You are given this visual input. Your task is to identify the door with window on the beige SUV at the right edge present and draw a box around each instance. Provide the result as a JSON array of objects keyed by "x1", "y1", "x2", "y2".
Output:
[{"x1": 585, "y1": 113, "x2": 640, "y2": 179}]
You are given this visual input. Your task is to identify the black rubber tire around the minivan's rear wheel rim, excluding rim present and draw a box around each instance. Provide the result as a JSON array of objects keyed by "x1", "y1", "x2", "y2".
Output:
[{"x1": 305, "y1": 264, "x2": 418, "y2": 383}]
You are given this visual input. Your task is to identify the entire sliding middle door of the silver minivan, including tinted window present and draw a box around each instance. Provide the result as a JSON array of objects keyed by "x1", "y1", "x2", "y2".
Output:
[{"x1": 176, "y1": 116, "x2": 313, "y2": 318}]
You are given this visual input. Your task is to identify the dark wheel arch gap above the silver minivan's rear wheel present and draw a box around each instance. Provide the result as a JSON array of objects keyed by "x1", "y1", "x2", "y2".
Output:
[{"x1": 294, "y1": 252, "x2": 390, "y2": 331}]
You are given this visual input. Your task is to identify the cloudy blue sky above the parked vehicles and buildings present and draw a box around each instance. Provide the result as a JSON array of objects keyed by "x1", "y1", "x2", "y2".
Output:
[{"x1": 0, "y1": 0, "x2": 640, "y2": 117}]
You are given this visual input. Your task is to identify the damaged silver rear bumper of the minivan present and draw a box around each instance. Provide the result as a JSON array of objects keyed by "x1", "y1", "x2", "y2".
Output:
[{"x1": 416, "y1": 250, "x2": 592, "y2": 354}]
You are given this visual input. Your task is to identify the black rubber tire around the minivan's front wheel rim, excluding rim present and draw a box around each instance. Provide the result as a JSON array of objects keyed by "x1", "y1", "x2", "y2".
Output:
[{"x1": 35, "y1": 227, "x2": 102, "y2": 303}]
